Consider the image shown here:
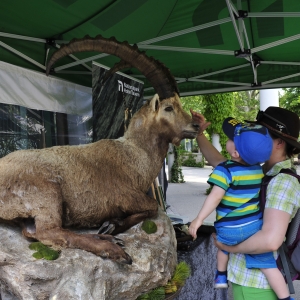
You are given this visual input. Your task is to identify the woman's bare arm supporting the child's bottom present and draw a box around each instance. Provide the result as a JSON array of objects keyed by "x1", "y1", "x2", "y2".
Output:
[{"x1": 215, "y1": 208, "x2": 291, "y2": 254}]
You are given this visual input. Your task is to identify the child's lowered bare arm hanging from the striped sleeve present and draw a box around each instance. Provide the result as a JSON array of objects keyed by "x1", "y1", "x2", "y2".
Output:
[{"x1": 189, "y1": 185, "x2": 225, "y2": 239}]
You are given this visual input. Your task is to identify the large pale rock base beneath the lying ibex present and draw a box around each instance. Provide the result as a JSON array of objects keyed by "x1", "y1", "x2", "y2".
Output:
[{"x1": 0, "y1": 211, "x2": 177, "y2": 300}]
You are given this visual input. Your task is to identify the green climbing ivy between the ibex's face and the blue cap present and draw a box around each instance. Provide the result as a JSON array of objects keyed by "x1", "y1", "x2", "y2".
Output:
[{"x1": 203, "y1": 93, "x2": 234, "y2": 157}]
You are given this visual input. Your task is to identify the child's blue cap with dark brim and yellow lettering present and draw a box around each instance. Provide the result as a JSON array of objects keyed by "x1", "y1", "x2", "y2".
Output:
[{"x1": 222, "y1": 117, "x2": 273, "y2": 165}]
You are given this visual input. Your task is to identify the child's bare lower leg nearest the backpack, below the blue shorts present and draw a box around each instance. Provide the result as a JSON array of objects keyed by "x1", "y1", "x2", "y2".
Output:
[{"x1": 260, "y1": 268, "x2": 290, "y2": 299}]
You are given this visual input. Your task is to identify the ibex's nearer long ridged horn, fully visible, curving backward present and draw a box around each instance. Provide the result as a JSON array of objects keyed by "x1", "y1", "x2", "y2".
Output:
[{"x1": 46, "y1": 35, "x2": 179, "y2": 100}]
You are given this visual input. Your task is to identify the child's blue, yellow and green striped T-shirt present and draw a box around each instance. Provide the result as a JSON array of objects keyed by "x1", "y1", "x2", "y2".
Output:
[{"x1": 207, "y1": 160, "x2": 264, "y2": 227}]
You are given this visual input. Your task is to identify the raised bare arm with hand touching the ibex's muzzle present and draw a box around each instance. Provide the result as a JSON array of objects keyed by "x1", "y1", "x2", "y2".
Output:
[{"x1": 190, "y1": 109, "x2": 226, "y2": 167}]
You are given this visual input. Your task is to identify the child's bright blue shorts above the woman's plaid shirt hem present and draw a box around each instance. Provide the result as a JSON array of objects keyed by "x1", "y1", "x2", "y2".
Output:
[{"x1": 216, "y1": 219, "x2": 277, "y2": 269}]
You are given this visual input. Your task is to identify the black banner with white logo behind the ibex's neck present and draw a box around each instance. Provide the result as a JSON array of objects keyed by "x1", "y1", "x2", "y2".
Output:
[{"x1": 92, "y1": 63, "x2": 144, "y2": 142}]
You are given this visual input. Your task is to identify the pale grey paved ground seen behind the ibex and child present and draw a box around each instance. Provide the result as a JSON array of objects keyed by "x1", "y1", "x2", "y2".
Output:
[{"x1": 166, "y1": 166, "x2": 300, "y2": 300}]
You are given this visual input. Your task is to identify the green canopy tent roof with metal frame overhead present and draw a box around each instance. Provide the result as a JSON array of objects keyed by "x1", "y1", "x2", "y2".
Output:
[{"x1": 0, "y1": 0, "x2": 300, "y2": 96}]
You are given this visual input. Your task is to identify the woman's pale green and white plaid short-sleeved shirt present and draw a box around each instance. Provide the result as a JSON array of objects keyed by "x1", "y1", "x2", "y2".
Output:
[{"x1": 228, "y1": 159, "x2": 300, "y2": 289}]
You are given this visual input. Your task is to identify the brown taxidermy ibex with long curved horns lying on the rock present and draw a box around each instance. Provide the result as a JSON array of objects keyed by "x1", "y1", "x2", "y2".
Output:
[{"x1": 0, "y1": 36, "x2": 198, "y2": 264}]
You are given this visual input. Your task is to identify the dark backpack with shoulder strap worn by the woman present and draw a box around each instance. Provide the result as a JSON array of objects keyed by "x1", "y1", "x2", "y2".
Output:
[{"x1": 260, "y1": 169, "x2": 300, "y2": 294}]
